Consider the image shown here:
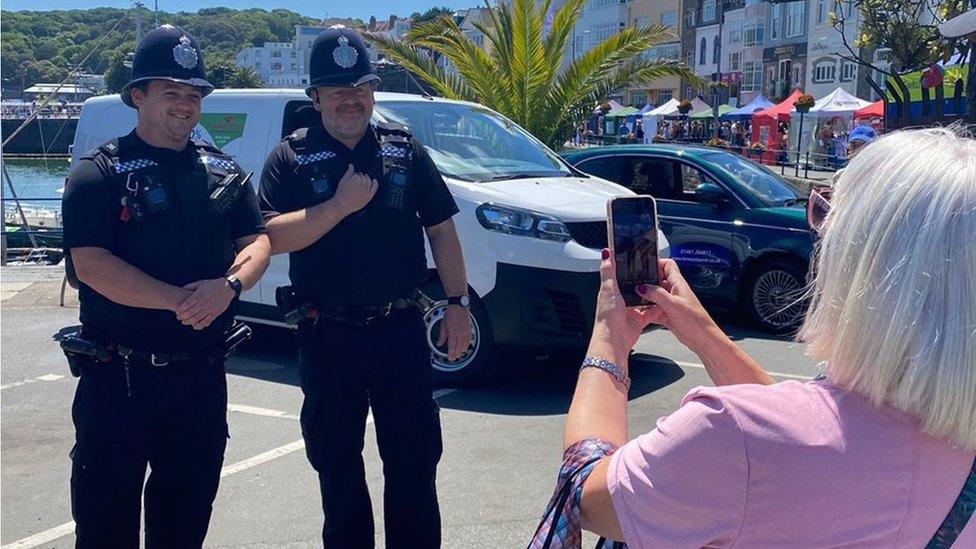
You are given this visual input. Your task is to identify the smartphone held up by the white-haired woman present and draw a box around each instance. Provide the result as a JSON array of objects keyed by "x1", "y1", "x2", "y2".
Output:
[{"x1": 607, "y1": 195, "x2": 660, "y2": 307}]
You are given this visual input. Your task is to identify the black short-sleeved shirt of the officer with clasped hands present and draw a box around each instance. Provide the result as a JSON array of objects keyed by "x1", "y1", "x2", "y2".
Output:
[{"x1": 62, "y1": 131, "x2": 265, "y2": 352}]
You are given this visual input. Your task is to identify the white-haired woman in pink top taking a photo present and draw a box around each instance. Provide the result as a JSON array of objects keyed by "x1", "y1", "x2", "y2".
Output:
[{"x1": 534, "y1": 129, "x2": 976, "y2": 548}]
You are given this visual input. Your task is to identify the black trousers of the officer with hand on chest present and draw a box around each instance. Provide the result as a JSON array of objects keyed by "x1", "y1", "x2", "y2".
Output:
[{"x1": 301, "y1": 311, "x2": 441, "y2": 549}]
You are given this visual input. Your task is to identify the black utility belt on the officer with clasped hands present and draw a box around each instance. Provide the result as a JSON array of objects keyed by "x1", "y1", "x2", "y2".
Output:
[{"x1": 60, "y1": 322, "x2": 251, "y2": 377}]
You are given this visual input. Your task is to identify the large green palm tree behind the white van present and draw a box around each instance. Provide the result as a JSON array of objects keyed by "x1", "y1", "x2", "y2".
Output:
[{"x1": 366, "y1": 0, "x2": 703, "y2": 148}]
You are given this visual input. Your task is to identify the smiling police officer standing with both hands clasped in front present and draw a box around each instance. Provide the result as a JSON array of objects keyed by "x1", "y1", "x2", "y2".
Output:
[{"x1": 62, "y1": 26, "x2": 270, "y2": 549}]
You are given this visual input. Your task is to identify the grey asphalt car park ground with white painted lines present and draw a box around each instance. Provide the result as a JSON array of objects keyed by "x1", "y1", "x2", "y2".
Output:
[{"x1": 0, "y1": 269, "x2": 818, "y2": 549}]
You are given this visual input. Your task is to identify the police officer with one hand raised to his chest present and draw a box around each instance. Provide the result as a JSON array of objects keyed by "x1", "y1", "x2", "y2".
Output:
[{"x1": 259, "y1": 28, "x2": 471, "y2": 549}]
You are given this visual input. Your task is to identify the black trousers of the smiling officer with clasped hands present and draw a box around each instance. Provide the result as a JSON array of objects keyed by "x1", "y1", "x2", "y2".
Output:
[{"x1": 71, "y1": 359, "x2": 228, "y2": 549}]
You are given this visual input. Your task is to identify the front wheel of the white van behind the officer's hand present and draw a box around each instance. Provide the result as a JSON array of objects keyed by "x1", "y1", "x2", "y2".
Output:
[{"x1": 423, "y1": 282, "x2": 495, "y2": 385}]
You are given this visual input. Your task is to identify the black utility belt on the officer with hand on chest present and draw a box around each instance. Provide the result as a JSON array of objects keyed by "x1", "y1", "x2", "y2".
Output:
[{"x1": 275, "y1": 286, "x2": 434, "y2": 326}]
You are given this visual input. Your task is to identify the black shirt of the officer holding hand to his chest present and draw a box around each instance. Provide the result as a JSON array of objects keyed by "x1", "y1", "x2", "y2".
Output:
[{"x1": 258, "y1": 125, "x2": 458, "y2": 307}]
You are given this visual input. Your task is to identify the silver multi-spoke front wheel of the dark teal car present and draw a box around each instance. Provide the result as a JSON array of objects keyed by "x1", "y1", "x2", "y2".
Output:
[{"x1": 745, "y1": 261, "x2": 808, "y2": 334}]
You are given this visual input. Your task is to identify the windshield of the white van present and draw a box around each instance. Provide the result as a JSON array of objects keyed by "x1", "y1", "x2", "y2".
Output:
[{"x1": 375, "y1": 101, "x2": 573, "y2": 182}]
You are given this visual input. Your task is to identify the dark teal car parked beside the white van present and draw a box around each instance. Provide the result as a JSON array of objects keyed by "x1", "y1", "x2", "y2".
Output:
[{"x1": 563, "y1": 145, "x2": 813, "y2": 332}]
